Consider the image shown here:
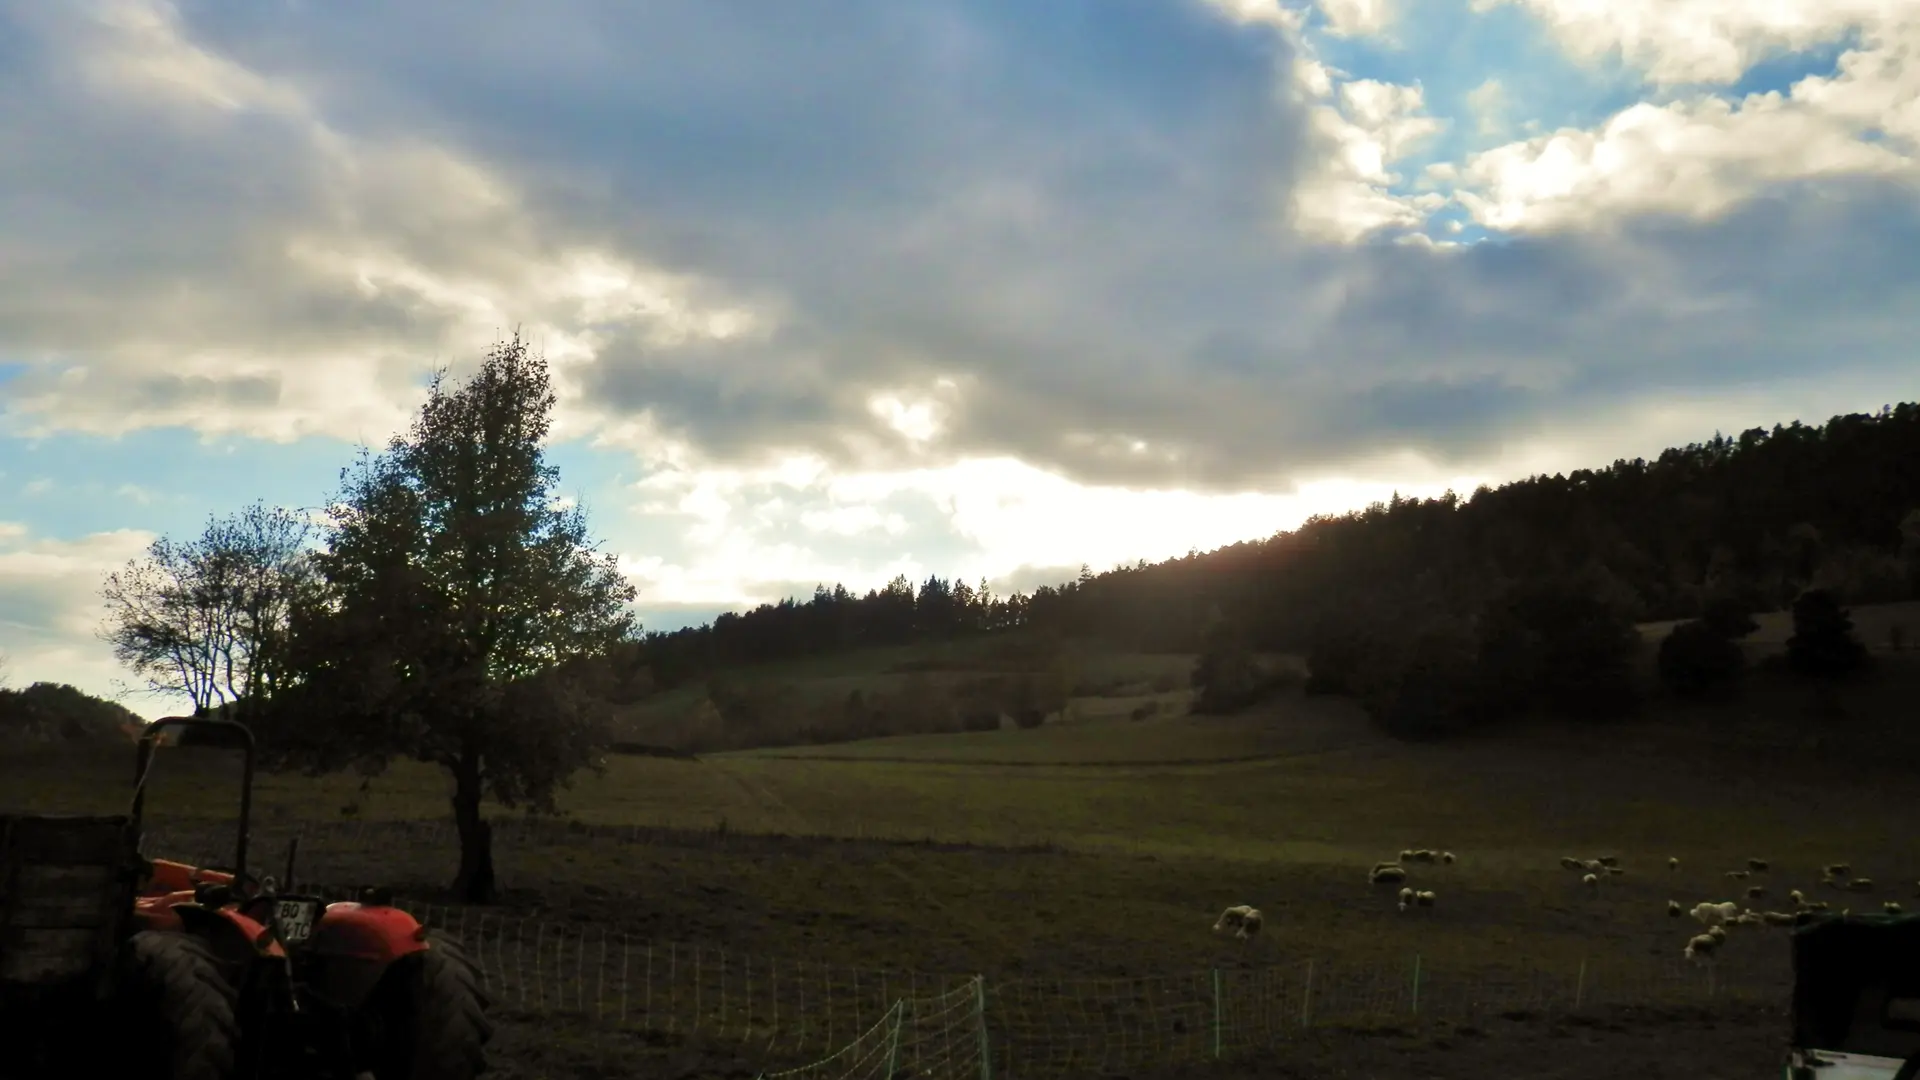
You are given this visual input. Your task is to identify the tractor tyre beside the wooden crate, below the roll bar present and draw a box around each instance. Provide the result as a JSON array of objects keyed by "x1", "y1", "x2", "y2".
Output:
[{"x1": 111, "y1": 930, "x2": 240, "y2": 1080}]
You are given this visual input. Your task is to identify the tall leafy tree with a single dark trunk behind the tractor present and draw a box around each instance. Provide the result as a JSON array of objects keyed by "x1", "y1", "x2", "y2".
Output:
[{"x1": 276, "y1": 332, "x2": 639, "y2": 903}]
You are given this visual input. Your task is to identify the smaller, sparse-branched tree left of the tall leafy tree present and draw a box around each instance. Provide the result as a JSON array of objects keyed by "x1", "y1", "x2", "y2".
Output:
[{"x1": 100, "y1": 502, "x2": 313, "y2": 711}]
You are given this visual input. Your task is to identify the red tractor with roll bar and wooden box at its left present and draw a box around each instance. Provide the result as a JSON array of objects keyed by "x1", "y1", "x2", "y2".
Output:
[{"x1": 0, "y1": 717, "x2": 492, "y2": 1080}]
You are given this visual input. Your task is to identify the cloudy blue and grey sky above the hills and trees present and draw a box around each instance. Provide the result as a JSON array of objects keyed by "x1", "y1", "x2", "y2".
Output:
[{"x1": 0, "y1": 0, "x2": 1920, "y2": 717}]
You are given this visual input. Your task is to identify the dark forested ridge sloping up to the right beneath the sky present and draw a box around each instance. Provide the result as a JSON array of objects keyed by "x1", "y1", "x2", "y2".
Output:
[{"x1": 634, "y1": 404, "x2": 1920, "y2": 686}]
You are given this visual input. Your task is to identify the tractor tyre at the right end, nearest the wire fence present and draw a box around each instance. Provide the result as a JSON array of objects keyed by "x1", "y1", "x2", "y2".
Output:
[{"x1": 367, "y1": 932, "x2": 493, "y2": 1080}]
